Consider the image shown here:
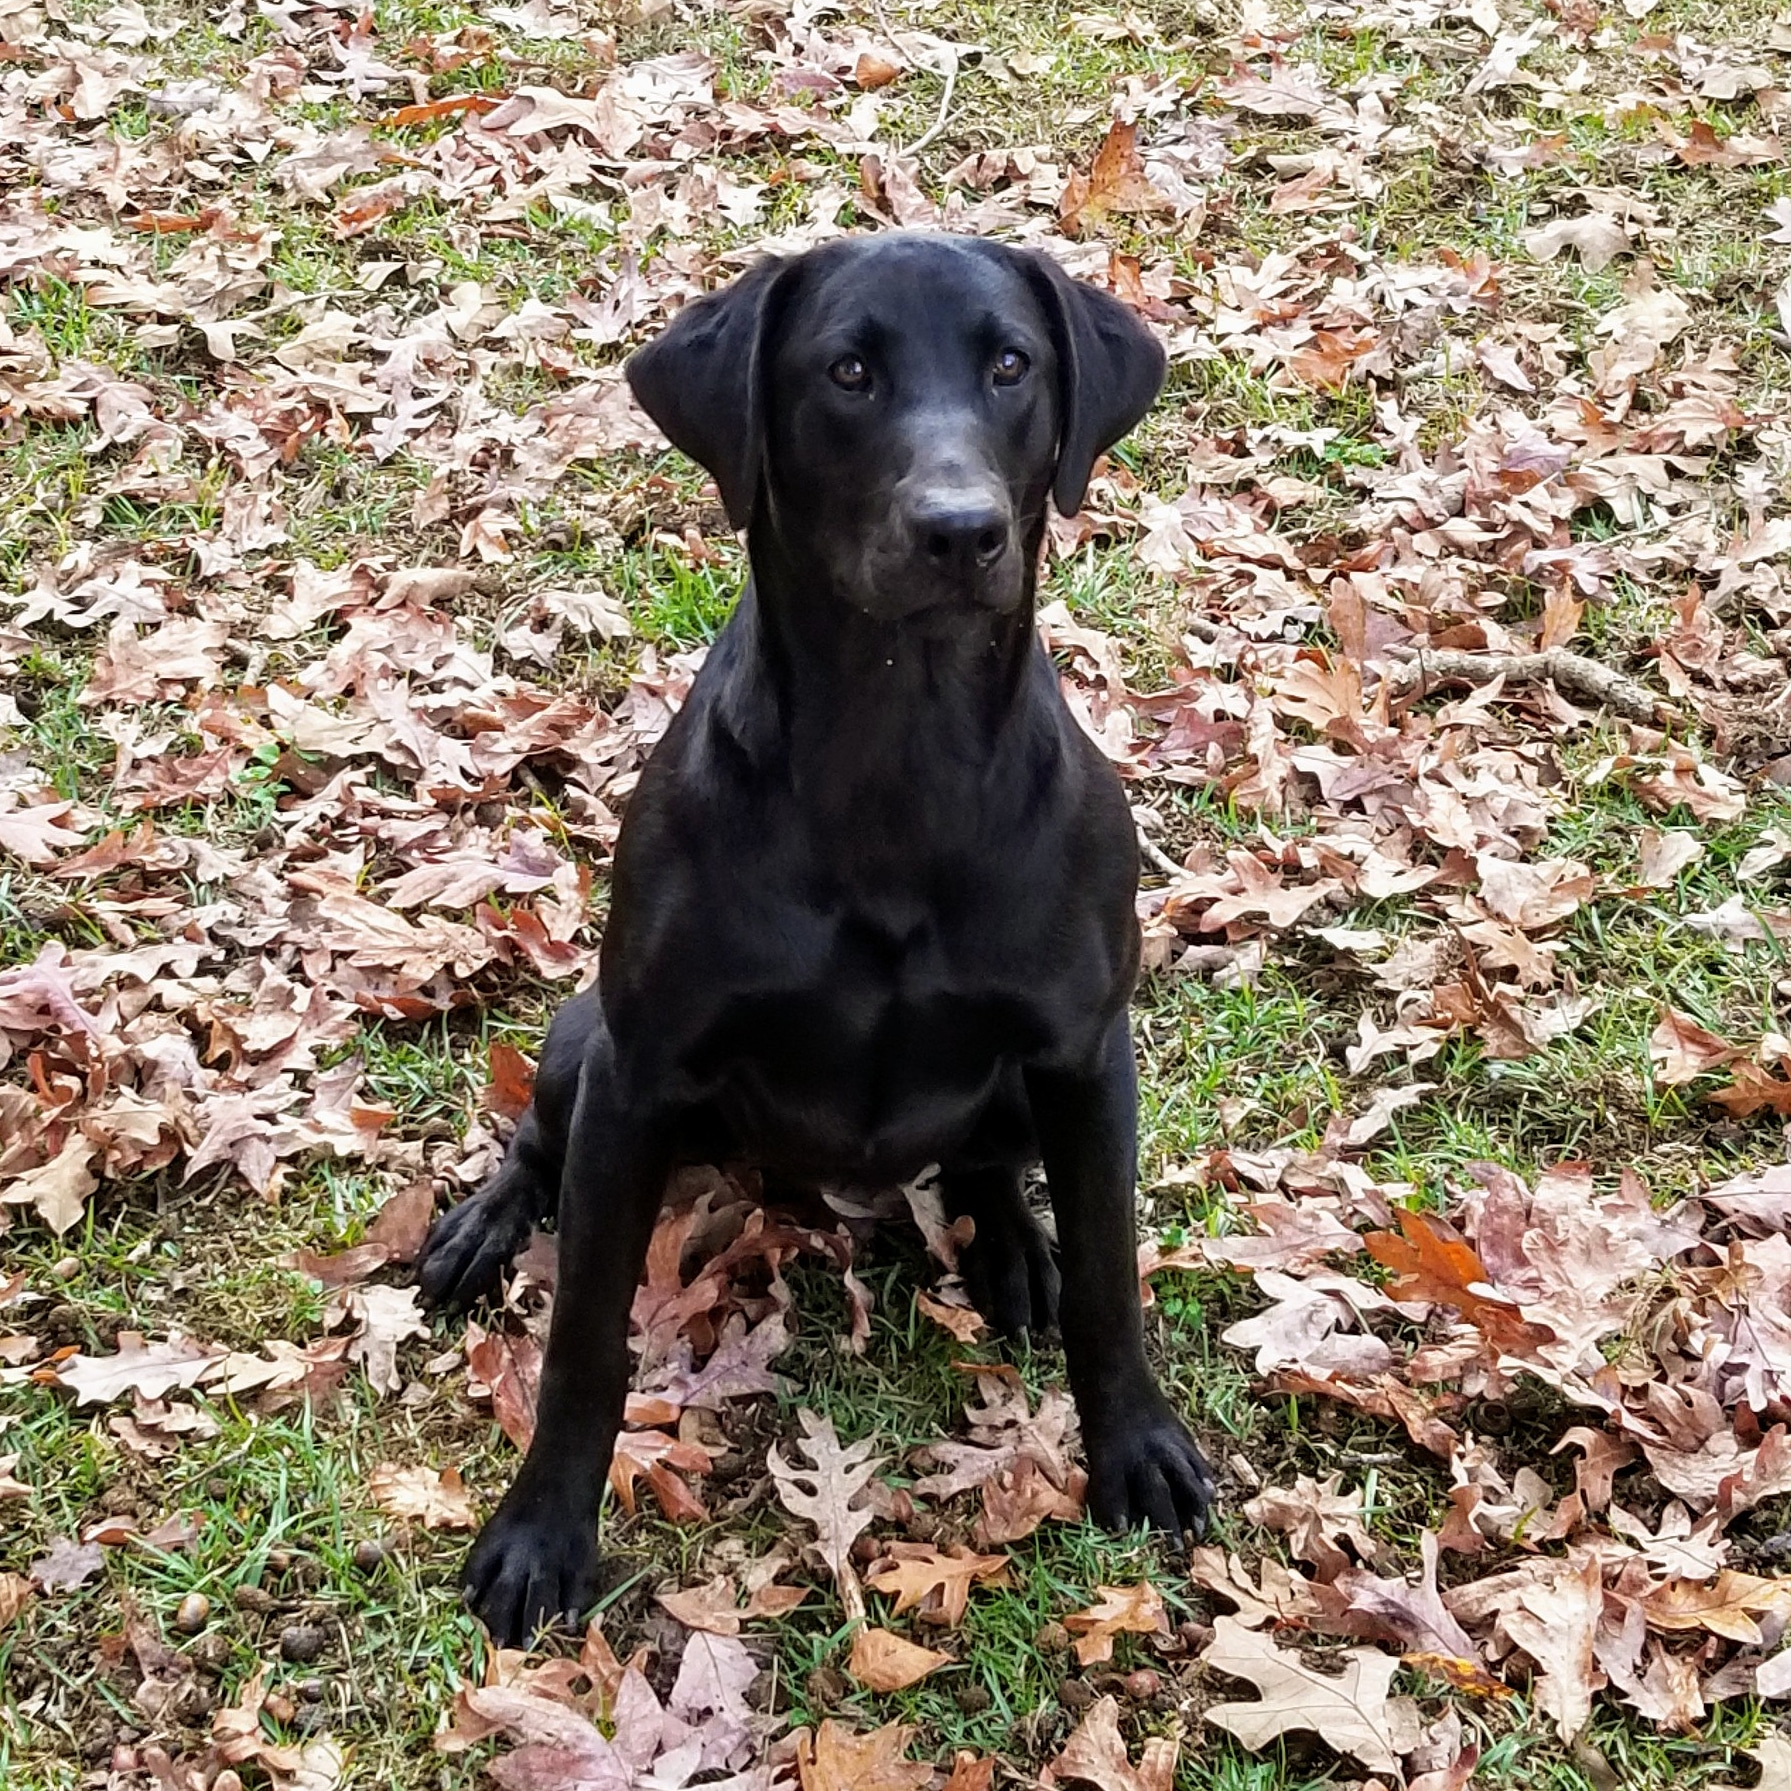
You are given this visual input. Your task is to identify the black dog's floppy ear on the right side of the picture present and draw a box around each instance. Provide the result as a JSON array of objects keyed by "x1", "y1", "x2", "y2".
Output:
[{"x1": 1030, "y1": 251, "x2": 1166, "y2": 516}]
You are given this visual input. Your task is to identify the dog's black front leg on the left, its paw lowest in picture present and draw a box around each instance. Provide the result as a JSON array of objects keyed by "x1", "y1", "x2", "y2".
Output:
[{"x1": 462, "y1": 1035, "x2": 670, "y2": 1648}]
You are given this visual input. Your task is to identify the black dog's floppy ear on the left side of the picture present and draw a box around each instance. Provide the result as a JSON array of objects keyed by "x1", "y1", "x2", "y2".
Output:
[{"x1": 625, "y1": 258, "x2": 790, "y2": 528}]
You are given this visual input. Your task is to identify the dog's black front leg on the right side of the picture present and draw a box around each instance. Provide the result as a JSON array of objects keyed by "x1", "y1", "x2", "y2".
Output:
[{"x1": 1026, "y1": 1015, "x2": 1213, "y2": 1535}]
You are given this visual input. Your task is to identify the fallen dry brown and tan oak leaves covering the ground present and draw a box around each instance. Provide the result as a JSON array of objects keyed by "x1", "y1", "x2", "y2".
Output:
[{"x1": 10, "y1": 0, "x2": 1791, "y2": 1791}]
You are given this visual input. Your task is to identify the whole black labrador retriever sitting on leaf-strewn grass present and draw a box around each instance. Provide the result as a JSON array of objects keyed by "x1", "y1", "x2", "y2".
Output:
[{"x1": 421, "y1": 233, "x2": 1213, "y2": 1642}]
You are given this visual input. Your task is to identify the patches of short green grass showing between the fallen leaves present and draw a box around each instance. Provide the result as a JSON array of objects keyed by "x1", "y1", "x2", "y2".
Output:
[{"x1": 10, "y1": 0, "x2": 1791, "y2": 1791}]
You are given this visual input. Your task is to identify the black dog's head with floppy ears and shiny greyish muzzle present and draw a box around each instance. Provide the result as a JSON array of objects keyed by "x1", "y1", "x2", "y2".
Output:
[{"x1": 627, "y1": 233, "x2": 1164, "y2": 620}]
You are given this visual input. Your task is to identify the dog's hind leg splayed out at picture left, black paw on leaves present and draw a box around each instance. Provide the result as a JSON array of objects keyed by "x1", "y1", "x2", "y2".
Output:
[{"x1": 417, "y1": 987, "x2": 604, "y2": 1306}]
